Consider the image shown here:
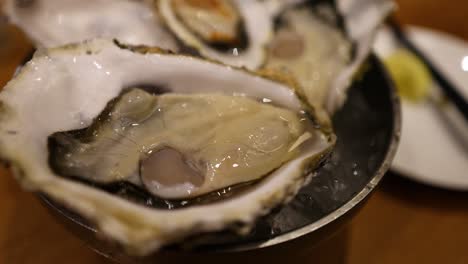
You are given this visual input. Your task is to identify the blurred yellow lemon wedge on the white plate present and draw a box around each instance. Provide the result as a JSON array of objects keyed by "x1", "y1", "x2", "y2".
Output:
[{"x1": 384, "y1": 49, "x2": 432, "y2": 103}]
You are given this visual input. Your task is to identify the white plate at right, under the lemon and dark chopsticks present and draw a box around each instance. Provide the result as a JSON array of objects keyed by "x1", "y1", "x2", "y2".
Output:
[{"x1": 375, "y1": 27, "x2": 468, "y2": 191}]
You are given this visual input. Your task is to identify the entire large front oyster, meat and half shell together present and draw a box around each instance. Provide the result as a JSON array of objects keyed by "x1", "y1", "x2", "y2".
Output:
[{"x1": 0, "y1": 40, "x2": 335, "y2": 255}]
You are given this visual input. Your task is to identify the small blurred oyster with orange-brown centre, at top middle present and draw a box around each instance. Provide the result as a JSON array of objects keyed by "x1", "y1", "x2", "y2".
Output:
[{"x1": 156, "y1": 0, "x2": 273, "y2": 69}]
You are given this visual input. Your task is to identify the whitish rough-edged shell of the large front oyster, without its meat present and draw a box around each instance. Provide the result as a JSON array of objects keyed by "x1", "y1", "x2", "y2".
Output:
[{"x1": 0, "y1": 40, "x2": 335, "y2": 255}]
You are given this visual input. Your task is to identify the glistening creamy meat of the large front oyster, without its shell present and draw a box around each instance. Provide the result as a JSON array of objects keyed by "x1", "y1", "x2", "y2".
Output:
[{"x1": 51, "y1": 89, "x2": 310, "y2": 199}]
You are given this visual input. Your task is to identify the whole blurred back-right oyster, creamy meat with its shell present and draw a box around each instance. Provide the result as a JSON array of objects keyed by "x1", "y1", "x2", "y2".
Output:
[{"x1": 264, "y1": 0, "x2": 394, "y2": 114}]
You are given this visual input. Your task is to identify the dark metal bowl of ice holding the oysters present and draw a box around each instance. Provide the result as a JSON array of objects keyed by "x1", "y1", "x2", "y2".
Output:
[{"x1": 40, "y1": 56, "x2": 401, "y2": 263}]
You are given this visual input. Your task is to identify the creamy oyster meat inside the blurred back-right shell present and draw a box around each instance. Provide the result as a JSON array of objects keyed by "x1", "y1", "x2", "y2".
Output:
[{"x1": 265, "y1": 7, "x2": 352, "y2": 115}]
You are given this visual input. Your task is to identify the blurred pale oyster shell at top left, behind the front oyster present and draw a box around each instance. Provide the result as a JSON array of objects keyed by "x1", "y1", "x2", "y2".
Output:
[{"x1": 4, "y1": 0, "x2": 178, "y2": 51}]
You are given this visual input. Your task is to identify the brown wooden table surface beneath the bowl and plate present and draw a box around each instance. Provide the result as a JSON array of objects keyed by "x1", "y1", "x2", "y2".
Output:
[{"x1": 0, "y1": 0, "x2": 468, "y2": 264}]
